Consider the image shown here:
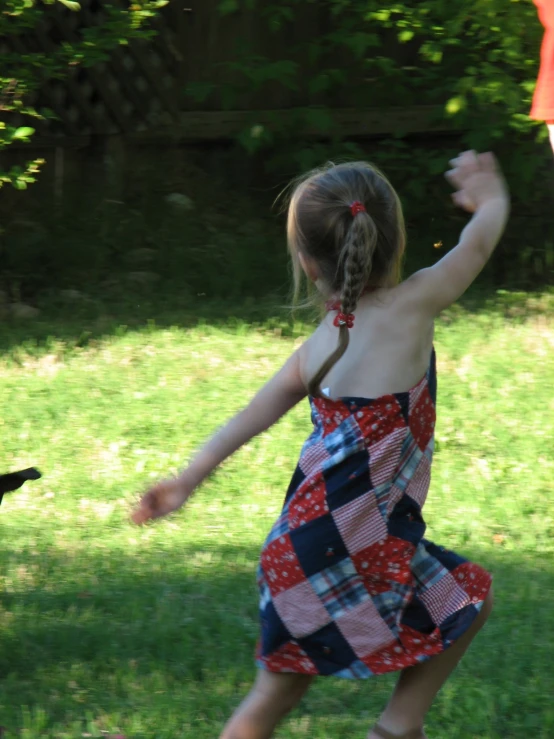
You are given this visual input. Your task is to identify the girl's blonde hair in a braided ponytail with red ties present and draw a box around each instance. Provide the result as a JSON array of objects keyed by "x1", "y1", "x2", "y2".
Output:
[{"x1": 287, "y1": 162, "x2": 406, "y2": 396}]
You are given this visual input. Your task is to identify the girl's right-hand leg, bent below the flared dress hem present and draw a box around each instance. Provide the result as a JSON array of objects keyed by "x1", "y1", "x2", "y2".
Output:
[{"x1": 368, "y1": 590, "x2": 493, "y2": 739}]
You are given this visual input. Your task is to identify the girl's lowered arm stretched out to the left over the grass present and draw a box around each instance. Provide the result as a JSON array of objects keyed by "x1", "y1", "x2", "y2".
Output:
[{"x1": 133, "y1": 347, "x2": 307, "y2": 523}]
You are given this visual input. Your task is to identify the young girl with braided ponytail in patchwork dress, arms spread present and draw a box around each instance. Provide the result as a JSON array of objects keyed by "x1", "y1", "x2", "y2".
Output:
[{"x1": 134, "y1": 152, "x2": 508, "y2": 739}]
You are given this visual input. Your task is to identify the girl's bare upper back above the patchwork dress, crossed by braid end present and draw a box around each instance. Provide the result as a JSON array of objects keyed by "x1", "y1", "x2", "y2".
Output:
[{"x1": 301, "y1": 280, "x2": 434, "y2": 398}]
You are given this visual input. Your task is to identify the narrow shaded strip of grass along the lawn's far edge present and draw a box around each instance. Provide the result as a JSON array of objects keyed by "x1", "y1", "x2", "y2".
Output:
[{"x1": 0, "y1": 285, "x2": 554, "y2": 353}]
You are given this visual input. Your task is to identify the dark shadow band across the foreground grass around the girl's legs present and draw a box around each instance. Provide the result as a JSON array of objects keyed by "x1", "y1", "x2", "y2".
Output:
[{"x1": 0, "y1": 547, "x2": 554, "y2": 736}]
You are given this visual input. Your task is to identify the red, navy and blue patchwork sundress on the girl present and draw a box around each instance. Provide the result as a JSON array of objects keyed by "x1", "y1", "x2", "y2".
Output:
[{"x1": 257, "y1": 352, "x2": 491, "y2": 678}]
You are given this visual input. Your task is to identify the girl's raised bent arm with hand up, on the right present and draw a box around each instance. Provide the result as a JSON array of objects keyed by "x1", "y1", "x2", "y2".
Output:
[{"x1": 404, "y1": 151, "x2": 509, "y2": 316}]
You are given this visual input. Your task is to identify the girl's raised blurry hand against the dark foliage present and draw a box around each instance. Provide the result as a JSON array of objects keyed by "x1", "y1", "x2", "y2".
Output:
[{"x1": 445, "y1": 151, "x2": 508, "y2": 213}]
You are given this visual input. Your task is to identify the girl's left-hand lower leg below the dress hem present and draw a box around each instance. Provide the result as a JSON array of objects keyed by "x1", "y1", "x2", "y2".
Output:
[{"x1": 219, "y1": 670, "x2": 313, "y2": 739}]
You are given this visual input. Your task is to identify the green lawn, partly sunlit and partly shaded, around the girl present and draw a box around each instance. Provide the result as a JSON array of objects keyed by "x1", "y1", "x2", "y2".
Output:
[{"x1": 0, "y1": 294, "x2": 554, "y2": 739}]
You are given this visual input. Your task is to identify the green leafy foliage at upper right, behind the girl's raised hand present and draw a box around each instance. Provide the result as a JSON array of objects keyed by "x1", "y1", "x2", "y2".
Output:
[{"x1": 184, "y1": 0, "x2": 554, "y2": 279}]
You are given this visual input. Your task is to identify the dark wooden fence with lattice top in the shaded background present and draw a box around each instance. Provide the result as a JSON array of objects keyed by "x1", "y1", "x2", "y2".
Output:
[{"x1": 0, "y1": 0, "x2": 458, "y2": 147}]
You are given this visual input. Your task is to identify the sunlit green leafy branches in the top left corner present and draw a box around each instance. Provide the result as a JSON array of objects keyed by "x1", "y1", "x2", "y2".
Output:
[{"x1": 0, "y1": 0, "x2": 167, "y2": 190}]
